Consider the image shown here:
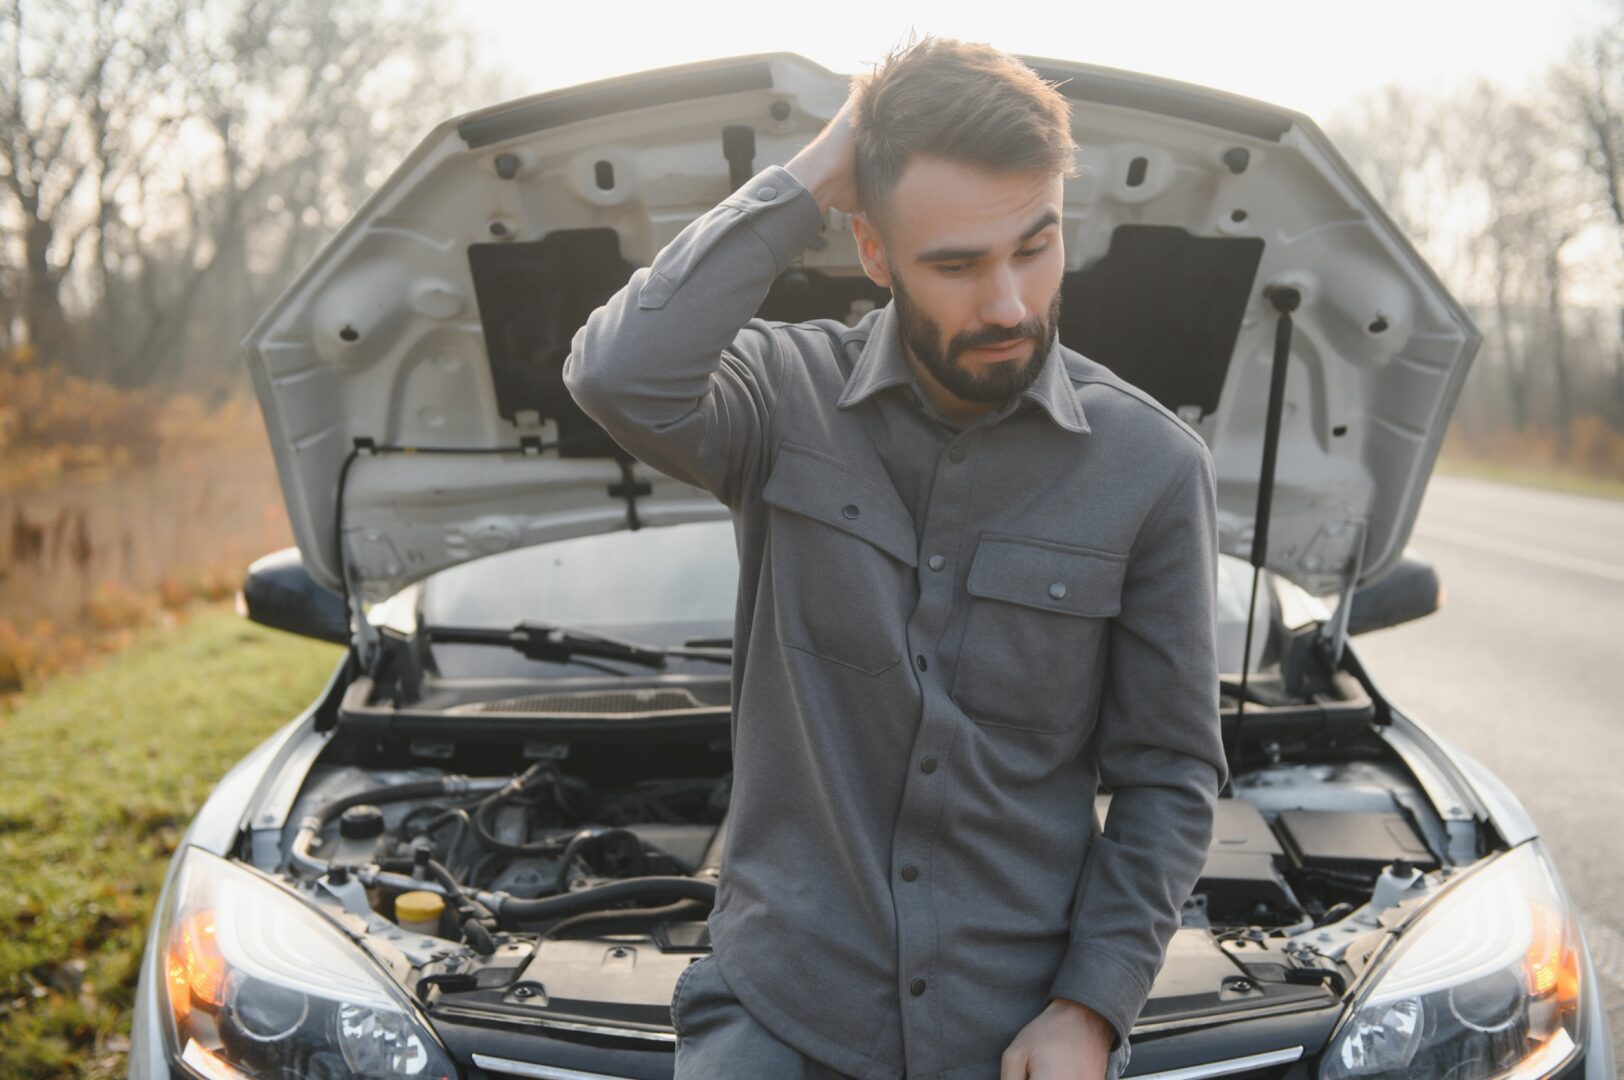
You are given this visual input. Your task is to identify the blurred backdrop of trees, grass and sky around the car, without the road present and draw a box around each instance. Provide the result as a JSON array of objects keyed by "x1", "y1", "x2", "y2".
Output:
[{"x1": 0, "y1": 0, "x2": 1624, "y2": 1077}]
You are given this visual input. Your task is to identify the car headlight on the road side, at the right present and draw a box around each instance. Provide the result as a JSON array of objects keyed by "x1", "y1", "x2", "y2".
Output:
[{"x1": 1320, "y1": 841, "x2": 1582, "y2": 1080}]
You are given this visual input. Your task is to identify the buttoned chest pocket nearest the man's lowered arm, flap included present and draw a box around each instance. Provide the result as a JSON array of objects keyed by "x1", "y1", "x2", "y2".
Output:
[{"x1": 952, "y1": 533, "x2": 1127, "y2": 732}]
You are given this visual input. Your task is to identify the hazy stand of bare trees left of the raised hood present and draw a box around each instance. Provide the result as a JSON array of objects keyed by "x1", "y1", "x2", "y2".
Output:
[{"x1": 0, "y1": 0, "x2": 497, "y2": 385}]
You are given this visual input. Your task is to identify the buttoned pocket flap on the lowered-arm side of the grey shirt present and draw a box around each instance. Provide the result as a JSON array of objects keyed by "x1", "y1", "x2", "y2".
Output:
[{"x1": 968, "y1": 534, "x2": 1127, "y2": 619}]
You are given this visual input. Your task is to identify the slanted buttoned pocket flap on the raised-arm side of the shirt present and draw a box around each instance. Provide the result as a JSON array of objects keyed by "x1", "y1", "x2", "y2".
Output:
[{"x1": 762, "y1": 443, "x2": 919, "y2": 570}]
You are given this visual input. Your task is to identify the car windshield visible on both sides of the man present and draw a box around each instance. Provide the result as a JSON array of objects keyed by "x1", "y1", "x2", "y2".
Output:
[{"x1": 422, "y1": 520, "x2": 1273, "y2": 672}]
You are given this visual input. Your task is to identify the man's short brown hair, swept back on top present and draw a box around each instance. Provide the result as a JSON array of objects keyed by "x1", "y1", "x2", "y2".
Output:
[{"x1": 854, "y1": 36, "x2": 1077, "y2": 218}]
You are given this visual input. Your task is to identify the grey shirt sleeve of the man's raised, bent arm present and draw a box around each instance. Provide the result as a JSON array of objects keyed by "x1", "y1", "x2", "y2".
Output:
[{"x1": 564, "y1": 166, "x2": 823, "y2": 505}]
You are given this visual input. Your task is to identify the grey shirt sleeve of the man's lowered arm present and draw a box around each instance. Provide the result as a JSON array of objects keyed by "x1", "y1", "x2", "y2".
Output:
[{"x1": 1049, "y1": 435, "x2": 1228, "y2": 1049}]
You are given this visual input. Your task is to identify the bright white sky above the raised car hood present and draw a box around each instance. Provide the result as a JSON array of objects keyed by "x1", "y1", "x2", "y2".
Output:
[{"x1": 461, "y1": 0, "x2": 1604, "y2": 122}]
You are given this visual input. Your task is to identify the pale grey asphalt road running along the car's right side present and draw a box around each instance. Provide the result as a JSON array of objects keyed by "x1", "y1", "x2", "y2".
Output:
[{"x1": 1354, "y1": 476, "x2": 1624, "y2": 1062}]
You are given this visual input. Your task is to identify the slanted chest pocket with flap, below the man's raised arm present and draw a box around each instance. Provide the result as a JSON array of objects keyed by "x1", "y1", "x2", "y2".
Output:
[{"x1": 762, "y1": 443, "x2": 919, "y2": 676}]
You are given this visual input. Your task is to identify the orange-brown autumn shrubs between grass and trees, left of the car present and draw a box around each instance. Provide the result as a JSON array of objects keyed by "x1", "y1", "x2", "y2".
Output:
[{"x1": 0, "y1": 348, "x2": 287, "y2": 697}]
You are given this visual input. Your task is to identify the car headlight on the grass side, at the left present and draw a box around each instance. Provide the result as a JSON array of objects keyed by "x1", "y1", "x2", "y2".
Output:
[{"x1": 159, "y1": 848, "x2": 456, "y2": 1080}]
